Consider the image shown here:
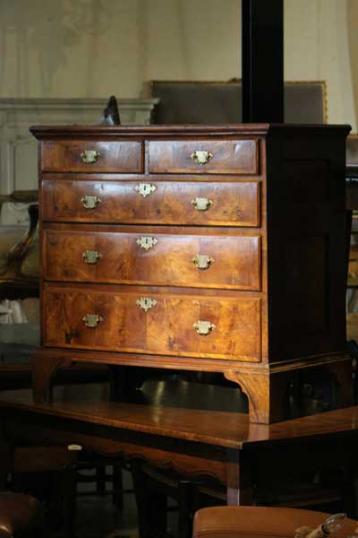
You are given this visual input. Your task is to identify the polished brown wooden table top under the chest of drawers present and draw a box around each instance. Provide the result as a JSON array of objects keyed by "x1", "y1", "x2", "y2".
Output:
[{"x1": 0, "y1": 389, "x2": 358, "y2": 449}]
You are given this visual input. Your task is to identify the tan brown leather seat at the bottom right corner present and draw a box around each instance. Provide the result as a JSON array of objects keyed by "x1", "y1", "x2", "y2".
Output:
[{"x1": 193, "y1": 506, "x2": 358, "y2": 538}]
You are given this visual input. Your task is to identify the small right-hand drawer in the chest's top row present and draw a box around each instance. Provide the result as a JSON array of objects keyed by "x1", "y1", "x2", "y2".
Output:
[{"x1": 148, "y1": 140, "x2": 258, "y2": 175}]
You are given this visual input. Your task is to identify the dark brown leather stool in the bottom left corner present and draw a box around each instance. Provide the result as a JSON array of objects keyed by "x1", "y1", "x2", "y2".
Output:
[{"x1": 0, "y1": 492, "x2": 45, "y2": 538}]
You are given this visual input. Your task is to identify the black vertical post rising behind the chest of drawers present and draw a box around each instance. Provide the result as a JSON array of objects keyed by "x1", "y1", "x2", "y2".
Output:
[{"x1": 242, "y1": 0, "x2": 284, "y2": 123}]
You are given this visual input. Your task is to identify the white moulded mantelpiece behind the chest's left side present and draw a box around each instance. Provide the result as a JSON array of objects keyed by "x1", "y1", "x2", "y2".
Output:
[{"x1": 0, "y1": 98, "x2": 158, "y2": 194}]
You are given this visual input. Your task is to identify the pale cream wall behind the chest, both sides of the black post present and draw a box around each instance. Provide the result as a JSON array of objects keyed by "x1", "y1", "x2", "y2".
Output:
[{"x1": 0, "y1": 0, "x2": 358, "y2": 130}]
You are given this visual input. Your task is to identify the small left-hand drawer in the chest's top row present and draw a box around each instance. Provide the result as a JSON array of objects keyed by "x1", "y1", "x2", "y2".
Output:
[{"x1": 41, "y1": 140, "x2": 143, "y2": 173}]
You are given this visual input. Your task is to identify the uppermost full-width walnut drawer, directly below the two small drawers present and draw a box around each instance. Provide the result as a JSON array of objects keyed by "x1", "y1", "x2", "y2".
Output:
[{"x1": 42, "y1": 179, "x2": 260, "y2": 226}]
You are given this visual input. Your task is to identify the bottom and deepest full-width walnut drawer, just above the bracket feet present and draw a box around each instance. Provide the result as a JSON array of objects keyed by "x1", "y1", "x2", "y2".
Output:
[{"x1": 43, "y1": 284, "x2": 261, "y2": 360}]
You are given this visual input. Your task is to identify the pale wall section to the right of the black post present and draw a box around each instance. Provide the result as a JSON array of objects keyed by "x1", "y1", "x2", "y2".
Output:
[{"x1": 284, "y1": 0, "x2": 358, "y2": 131}]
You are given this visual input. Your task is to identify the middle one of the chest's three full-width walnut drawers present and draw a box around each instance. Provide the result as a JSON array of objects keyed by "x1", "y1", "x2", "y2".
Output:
[{"x1": 43, "y1": 225, "x2": 260, "y2": 290}]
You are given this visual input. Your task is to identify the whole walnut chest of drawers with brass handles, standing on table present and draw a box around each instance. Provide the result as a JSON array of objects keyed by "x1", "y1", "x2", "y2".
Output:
[{"x1": 32, "y1": 125, "x2": 351, "y2": 423}]
